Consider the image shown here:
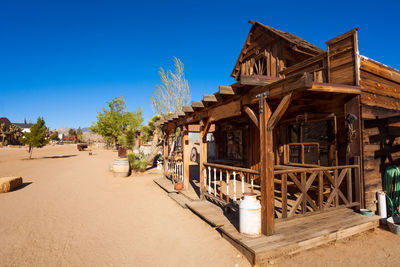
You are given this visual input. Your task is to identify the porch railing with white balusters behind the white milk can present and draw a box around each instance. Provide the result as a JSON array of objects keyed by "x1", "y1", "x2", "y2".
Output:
[{"x1": 202, "y1": 163, "x2": 260, "y2": 204}]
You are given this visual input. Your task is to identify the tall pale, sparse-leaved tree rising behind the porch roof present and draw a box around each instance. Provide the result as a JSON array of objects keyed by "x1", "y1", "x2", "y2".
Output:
[{"x1": 150, "y1": 57, "x2": 190, "y2": 114}]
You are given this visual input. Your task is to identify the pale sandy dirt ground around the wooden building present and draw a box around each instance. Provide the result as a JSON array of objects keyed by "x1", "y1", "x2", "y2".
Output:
[{"x1": 0, "y1": 145, "x2": 400, "y2": 266}]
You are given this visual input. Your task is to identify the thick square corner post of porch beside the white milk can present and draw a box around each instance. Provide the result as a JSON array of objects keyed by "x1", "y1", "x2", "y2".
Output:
[{"x1": 260, "y1": 95, "x2": 275, "y2": 235}]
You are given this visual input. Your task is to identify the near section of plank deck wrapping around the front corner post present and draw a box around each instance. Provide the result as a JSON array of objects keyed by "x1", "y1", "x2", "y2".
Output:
[{"x1": 187, "y1": 201, "x2": 379, "y2": 265}]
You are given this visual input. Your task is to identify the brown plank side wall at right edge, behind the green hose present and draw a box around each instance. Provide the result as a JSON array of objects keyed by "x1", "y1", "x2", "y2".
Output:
[{"x1": 360, "y1": 57, "x2": 400, "y2": 210}]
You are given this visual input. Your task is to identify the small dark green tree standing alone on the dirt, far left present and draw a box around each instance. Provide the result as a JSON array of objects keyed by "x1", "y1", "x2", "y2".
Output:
[{"x1": 20, "y1": 117, "x2": 50, "y2": 159}]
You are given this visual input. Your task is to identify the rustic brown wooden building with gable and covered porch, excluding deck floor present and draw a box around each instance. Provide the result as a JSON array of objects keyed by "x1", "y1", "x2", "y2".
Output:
[{"x1": 157, "y1": 21, "x2": 400, "y2": 264}]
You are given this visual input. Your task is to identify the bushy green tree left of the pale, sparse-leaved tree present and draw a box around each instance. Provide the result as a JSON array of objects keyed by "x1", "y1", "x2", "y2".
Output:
[{"x1": 90, "y1": 97, "x2": 143, "y2": 146}]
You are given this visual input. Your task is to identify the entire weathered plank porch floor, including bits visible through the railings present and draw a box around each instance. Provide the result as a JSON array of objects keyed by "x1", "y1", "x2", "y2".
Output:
[{"x1": 155, "y1": 177, "x2": 379, "y2": 265}]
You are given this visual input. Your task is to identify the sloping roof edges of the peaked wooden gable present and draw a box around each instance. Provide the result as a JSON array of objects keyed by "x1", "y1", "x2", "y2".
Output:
[{"x1": 231, "y1": 20, "x2": 325, "y2": 77}]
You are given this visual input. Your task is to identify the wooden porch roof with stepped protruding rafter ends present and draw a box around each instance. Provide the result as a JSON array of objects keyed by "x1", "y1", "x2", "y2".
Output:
[{"x1": 159, "y1": 72, "x2": 361, "y2": 130}]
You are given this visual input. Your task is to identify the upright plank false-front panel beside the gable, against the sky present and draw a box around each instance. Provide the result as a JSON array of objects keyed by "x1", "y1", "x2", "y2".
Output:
[{"x1": 326, "y1": 29, "x2": 358, "y2": 85}]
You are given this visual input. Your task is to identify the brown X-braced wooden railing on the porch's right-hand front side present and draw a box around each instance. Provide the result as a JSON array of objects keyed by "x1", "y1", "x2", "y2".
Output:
[{"x1": 274, "y1": 165, "x2": 360, "y2": 218}]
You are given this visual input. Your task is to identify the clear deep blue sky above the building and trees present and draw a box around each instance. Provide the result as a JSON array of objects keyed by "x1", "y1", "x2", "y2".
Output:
[{"x1": 0, "y1": 0, "x2": 400, "y2": 128}]
